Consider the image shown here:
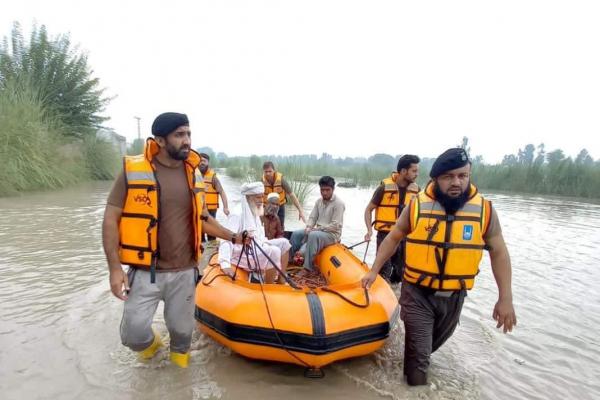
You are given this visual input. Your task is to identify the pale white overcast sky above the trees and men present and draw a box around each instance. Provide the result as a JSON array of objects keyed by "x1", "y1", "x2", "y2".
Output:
[{"x1": 0, "y1": 0, "x2": 600, "y2": 162}]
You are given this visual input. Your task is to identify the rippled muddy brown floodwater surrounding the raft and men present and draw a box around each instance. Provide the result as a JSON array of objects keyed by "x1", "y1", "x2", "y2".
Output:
[{"x1": 0, "y1": 176, "x2": 600, "y2": 399}]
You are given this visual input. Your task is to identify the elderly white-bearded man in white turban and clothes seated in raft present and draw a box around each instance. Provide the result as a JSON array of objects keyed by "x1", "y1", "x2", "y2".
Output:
[{"x1": 219, "y1": 182, "x2": 291, "y2": 283}]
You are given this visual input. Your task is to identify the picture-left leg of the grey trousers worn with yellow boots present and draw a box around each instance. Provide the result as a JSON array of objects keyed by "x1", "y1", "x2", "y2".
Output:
[{"x1": 121, "y1": 270, "x2": 162, "y2": 351}]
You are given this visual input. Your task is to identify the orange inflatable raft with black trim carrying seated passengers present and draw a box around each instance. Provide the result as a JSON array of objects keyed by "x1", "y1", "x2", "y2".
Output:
[{"x1": 195, "y1": 244, "x2": 399, "y2": 368}]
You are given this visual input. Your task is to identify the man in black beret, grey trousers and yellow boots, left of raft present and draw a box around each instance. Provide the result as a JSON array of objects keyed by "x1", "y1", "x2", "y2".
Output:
[{"x1": 102, "y1": 112, "x2": 247, "y2": 368}]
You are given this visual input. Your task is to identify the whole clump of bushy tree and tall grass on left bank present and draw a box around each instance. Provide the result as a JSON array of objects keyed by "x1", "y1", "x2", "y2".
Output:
[{"x1": 0, "y1": 23, "x2": 119, "y2": 196}]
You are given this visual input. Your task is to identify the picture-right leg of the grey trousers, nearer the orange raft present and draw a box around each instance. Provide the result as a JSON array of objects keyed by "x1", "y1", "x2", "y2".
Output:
[{"x1": 159, "y1": 269, "x2": 196, "y2": 353}]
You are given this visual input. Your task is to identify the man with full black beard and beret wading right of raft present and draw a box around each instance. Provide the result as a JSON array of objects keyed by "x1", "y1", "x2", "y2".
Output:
[{"x1": 362, "y1": 148, "x2": 517, "y2": 385}]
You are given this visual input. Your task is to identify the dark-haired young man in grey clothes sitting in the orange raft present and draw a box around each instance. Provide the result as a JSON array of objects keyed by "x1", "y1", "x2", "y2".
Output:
[{"x1": 291, "y1": 176, "x2": 346, "y2": 271}]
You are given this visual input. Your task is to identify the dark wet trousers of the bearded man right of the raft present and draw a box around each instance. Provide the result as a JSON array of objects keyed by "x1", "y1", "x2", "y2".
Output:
[{"x1": 400, "y1": 282, "x2": 467, "y2": 385}]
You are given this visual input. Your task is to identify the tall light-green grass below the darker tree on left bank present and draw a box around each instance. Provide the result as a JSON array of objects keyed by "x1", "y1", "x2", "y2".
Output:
[{"x1": 0, "y1": 79, "x2": 119, "y2": 196}]
